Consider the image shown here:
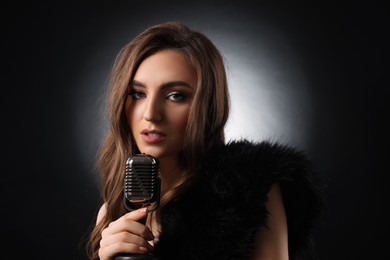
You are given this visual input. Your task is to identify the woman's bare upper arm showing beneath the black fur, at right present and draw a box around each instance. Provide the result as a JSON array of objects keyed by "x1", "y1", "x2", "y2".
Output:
[{"x1": 253, "y1": 183, "x2": 288, "y2": 260}]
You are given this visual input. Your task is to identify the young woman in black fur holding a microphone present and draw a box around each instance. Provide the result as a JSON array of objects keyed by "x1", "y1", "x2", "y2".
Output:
[{"x1": 88, "y1": 22, "x2": 322, "y2": 260}]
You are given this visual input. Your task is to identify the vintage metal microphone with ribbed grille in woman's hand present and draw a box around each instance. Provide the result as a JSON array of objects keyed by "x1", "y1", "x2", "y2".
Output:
[{"x1": 114, "y1": 154, "x2": 161, "y2": 260}]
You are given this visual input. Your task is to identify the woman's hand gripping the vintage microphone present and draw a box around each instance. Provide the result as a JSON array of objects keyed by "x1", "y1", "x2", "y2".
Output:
[{"x1": 99, "y1": 208, "x2": 154, "y2": 260}]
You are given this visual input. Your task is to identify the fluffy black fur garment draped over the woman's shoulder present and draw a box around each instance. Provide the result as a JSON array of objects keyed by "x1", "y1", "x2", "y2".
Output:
[{"x1": 154, "y1": 140, "x2": 323, "y2": 260}]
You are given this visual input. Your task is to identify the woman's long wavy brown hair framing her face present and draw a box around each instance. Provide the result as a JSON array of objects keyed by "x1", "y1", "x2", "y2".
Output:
[{"x1": 87, "y1": 22, "x2": 229, "y2": 259}]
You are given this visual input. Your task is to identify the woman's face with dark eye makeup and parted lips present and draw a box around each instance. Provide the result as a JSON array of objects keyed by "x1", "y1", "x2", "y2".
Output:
[{"x1": 126, "y1": 50, "x2": 196, "y2": 159}]
